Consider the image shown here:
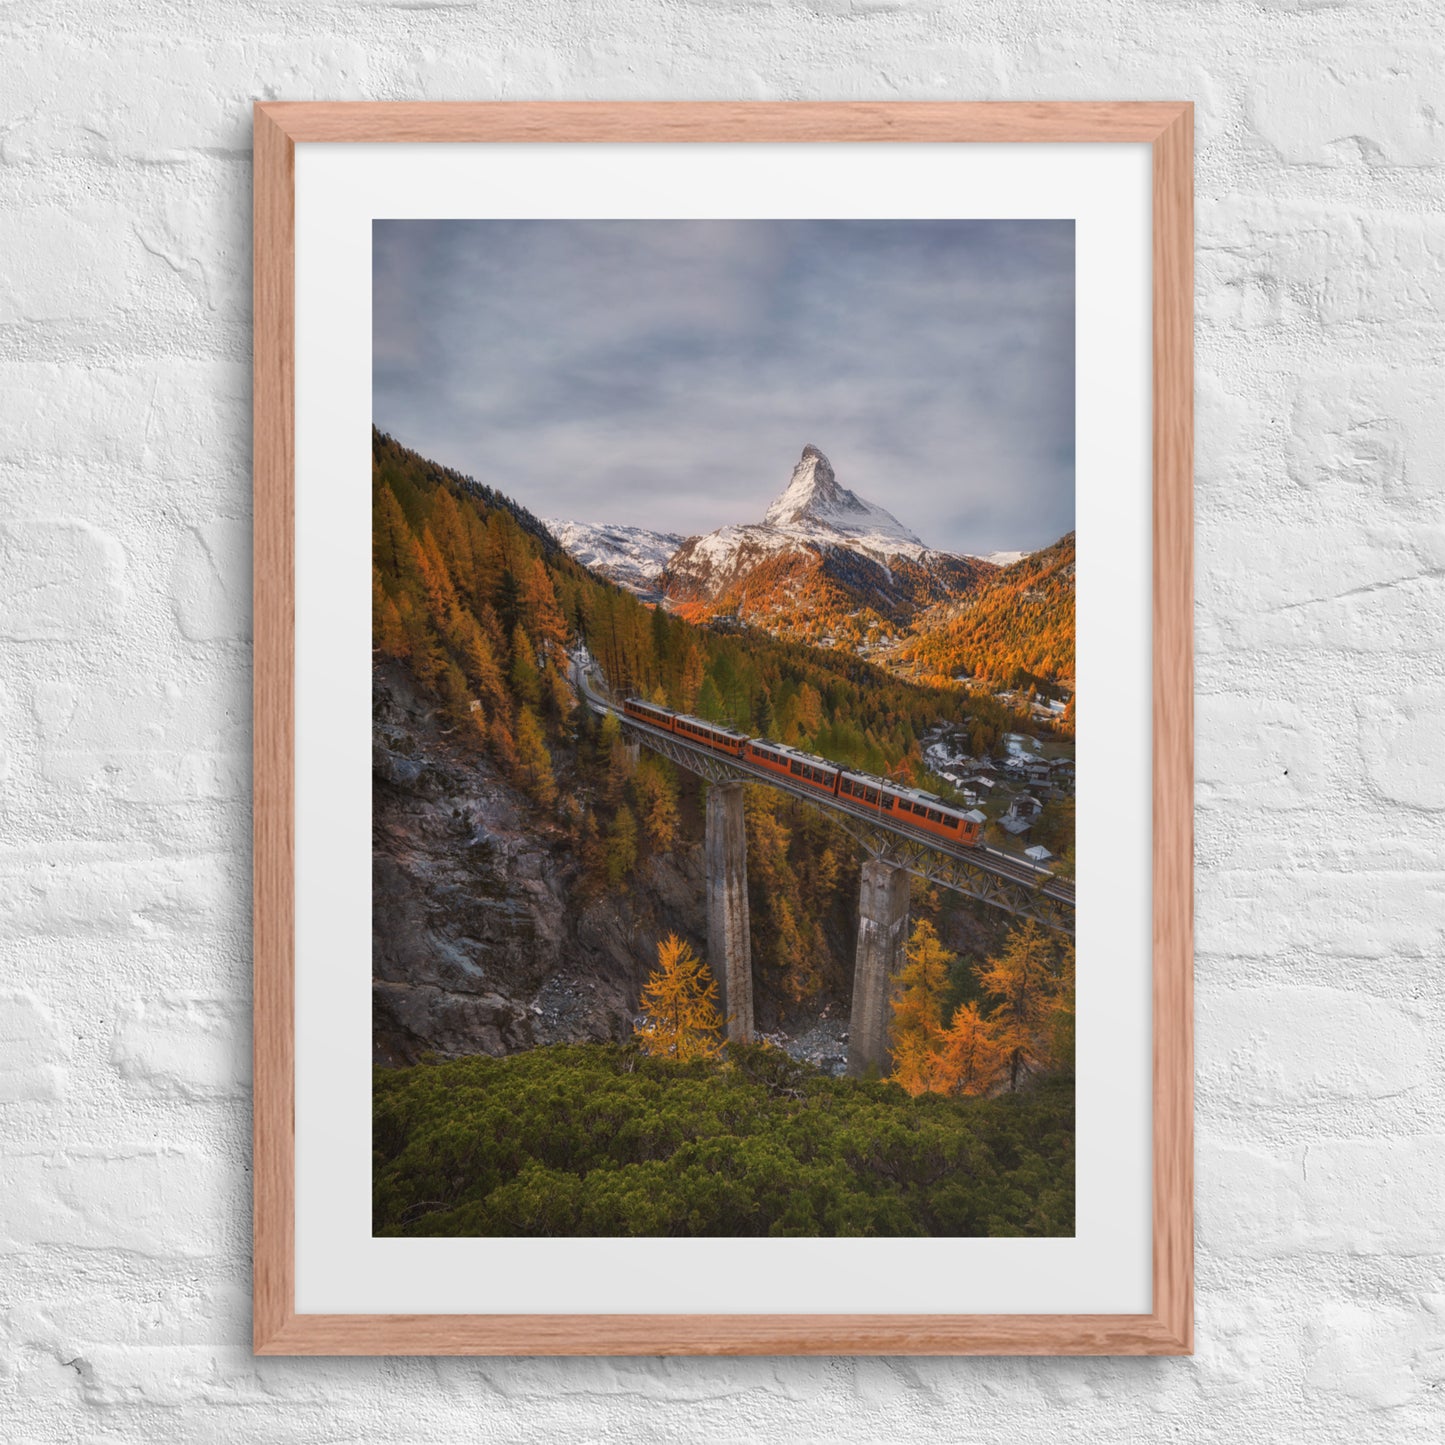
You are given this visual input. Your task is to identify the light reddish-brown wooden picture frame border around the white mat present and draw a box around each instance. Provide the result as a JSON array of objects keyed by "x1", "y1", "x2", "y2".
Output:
[{"x1": 254, "y1": 103, "x2": 1194, "y2": 1355}]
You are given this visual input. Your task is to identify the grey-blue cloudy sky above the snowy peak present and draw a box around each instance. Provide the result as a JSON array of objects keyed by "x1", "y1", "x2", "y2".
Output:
[{"x1": 373, "y1": 221, "x2": 1074, "y2": 553}]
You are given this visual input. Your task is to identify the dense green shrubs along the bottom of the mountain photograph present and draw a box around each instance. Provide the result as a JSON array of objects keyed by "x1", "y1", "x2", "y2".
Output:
[{"x1": 373, "y1": 1043, "x2": 1074, "y2": 1235}]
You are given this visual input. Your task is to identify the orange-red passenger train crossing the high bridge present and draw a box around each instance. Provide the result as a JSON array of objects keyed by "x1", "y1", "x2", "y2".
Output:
[{"x1": 623, "y1": 698, "x2": 983, "y2": 848}]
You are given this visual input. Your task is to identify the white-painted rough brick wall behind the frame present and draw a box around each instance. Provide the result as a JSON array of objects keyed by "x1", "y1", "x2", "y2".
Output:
[{"x1": 0, "y1": 0, "x2": 1445, "y2": 1445}]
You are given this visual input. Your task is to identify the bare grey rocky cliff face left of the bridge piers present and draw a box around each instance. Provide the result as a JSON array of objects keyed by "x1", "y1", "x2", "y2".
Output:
[{"x1": 371, "y1": 663, "x2": 707, "y2": 1064}]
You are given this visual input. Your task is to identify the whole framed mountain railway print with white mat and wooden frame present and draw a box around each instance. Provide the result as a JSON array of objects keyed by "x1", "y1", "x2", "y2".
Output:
[{"x1": 254, "y1": 103, "x2": 1194, "y2": 1354}]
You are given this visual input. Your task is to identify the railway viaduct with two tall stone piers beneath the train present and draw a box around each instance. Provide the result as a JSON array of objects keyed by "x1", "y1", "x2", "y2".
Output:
[{"x1": 572, "y1": 659, "x2": 1074, "y2": 1078}]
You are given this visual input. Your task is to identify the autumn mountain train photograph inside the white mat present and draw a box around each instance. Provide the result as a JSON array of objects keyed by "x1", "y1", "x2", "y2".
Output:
[{"x1": 371, "y1": 220, "x2": 1088, "y2": 1237}]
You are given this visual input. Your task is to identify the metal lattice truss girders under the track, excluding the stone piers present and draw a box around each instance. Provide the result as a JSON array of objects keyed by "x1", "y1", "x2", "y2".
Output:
[{"x1": 621, "y1": 717, "x2": 1074, "y2": 933}]
